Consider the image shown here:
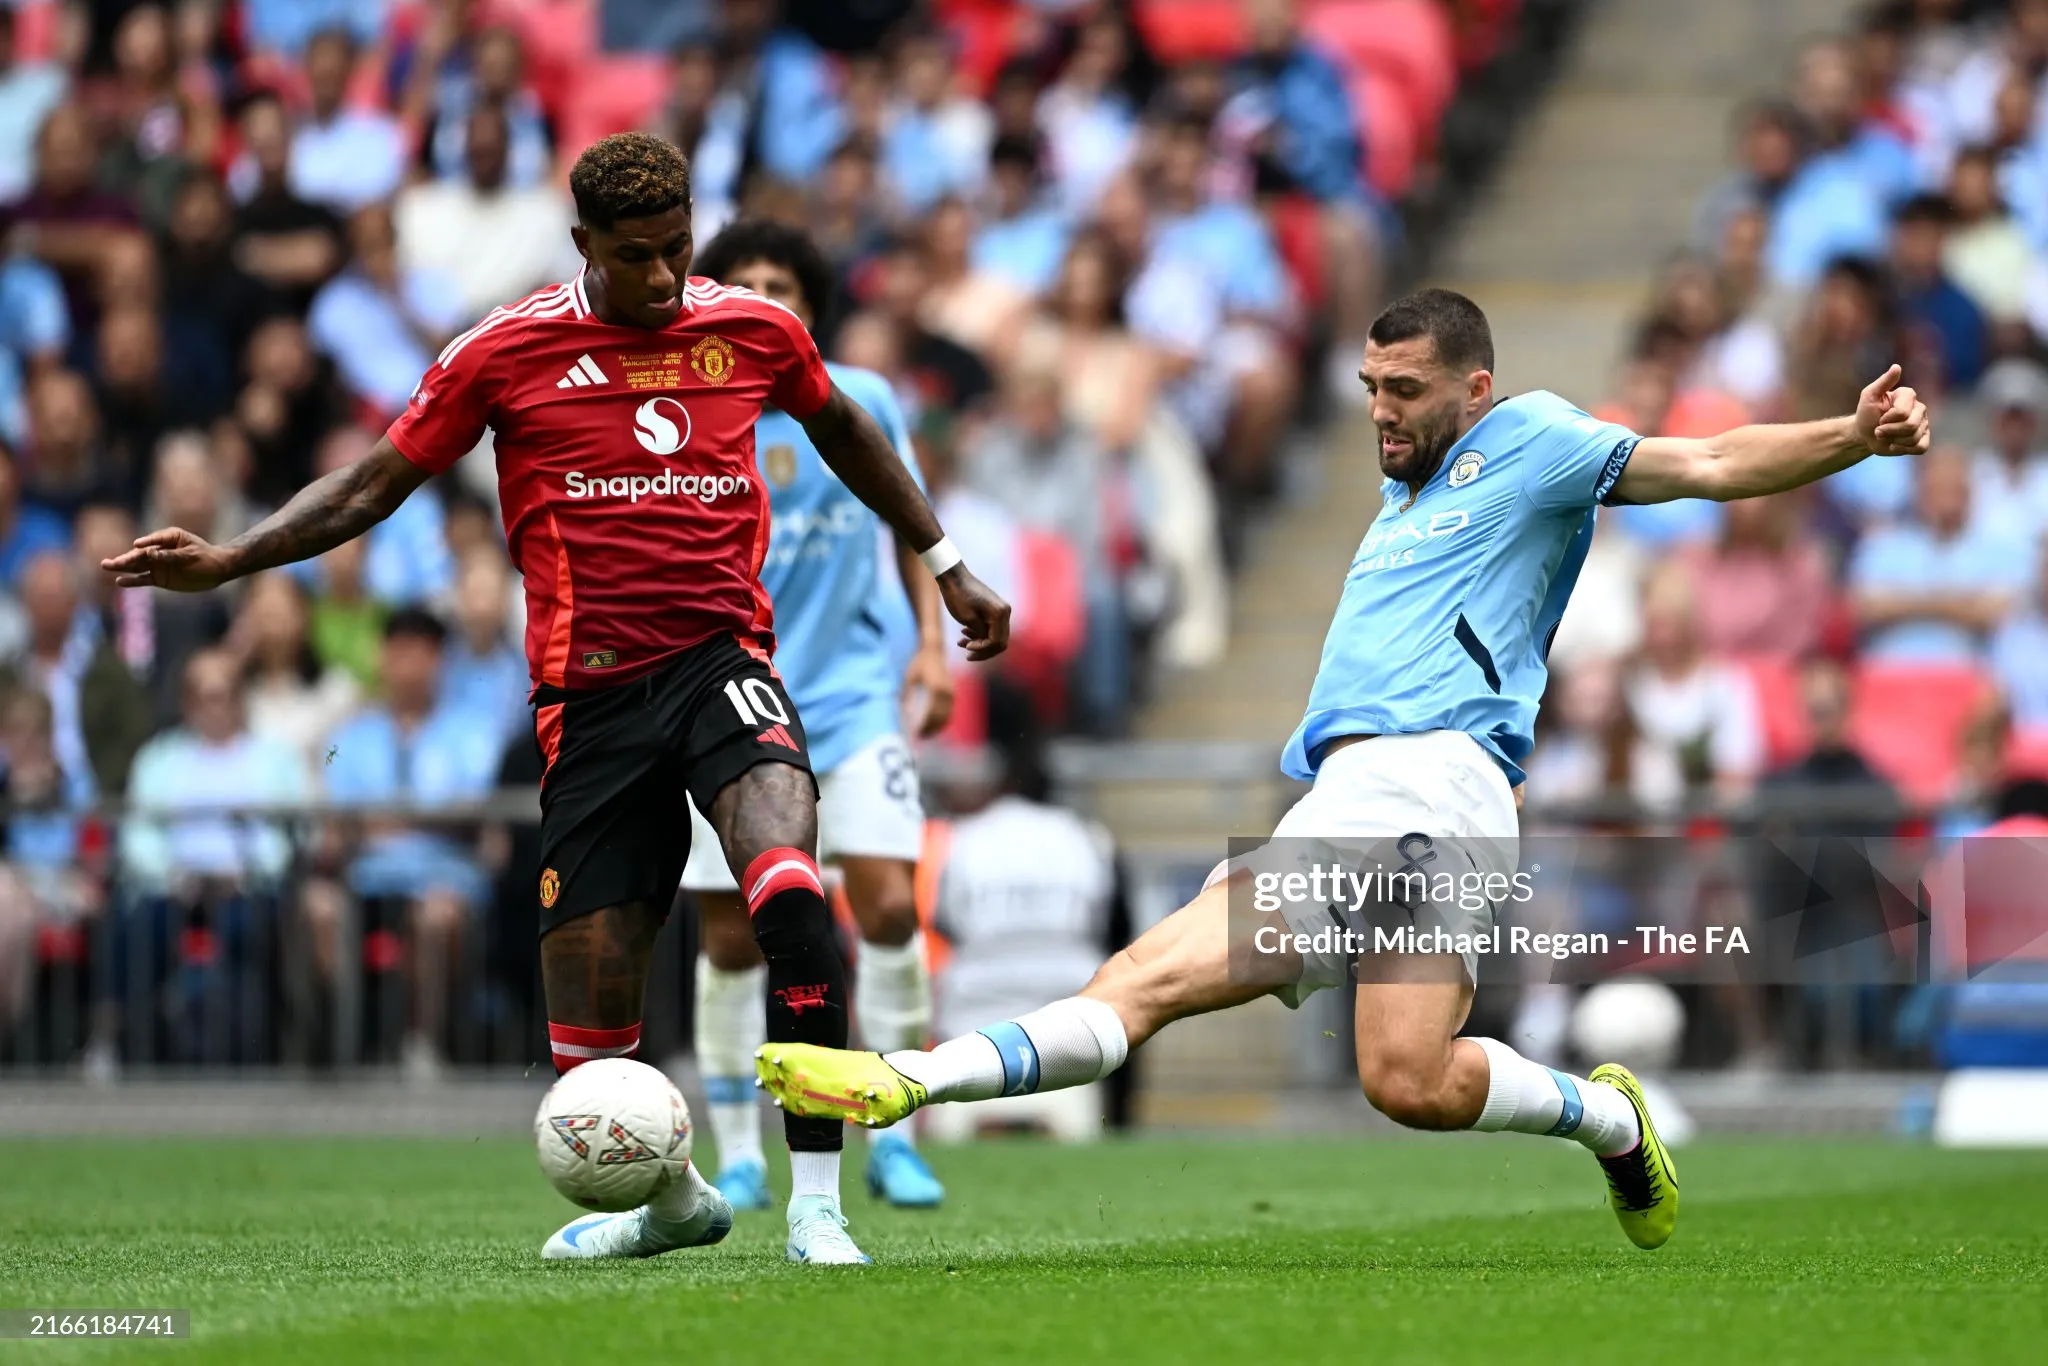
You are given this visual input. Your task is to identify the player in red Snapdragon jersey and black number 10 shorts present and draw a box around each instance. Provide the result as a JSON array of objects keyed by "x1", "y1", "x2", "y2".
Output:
[{"x1": 102, "y1": 133, "x2": 1010, "y2": 1262}]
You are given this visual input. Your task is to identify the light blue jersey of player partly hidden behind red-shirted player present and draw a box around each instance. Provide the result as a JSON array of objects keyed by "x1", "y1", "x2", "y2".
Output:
[{"x1": 754, "y1": 365, "x2": 924, "y2": 774}]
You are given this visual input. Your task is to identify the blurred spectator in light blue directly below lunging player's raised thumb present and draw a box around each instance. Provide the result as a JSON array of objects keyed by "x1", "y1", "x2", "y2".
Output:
[{"x1": 1849, "y1": 449, "x2": 2034, "y2": 664}]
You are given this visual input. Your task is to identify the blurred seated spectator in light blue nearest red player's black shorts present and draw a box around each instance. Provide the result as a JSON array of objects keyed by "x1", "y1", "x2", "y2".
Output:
[{"x1": 305, "y1": 608, "x2": 500, "y2": 1073}]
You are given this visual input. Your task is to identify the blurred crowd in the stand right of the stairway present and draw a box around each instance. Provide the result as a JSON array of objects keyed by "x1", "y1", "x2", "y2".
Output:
[{"x1": 1530, "y1": 0, "x2": 2048, "y2": 831}]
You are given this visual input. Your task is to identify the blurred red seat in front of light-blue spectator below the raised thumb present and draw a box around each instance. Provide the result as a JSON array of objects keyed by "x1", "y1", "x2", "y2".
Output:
[{"x1": 1849, "y1": 664, "x2": 1991, "y2": 803}]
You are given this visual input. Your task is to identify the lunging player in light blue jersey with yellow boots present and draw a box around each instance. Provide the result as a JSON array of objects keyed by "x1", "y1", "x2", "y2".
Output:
[{"x1": 756, "y1": 289, "x2": 1927, "y2": 1247}]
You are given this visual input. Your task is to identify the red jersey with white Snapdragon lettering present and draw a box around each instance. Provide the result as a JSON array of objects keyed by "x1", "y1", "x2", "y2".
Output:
[{"x1": 389, "y1": 274, "x2": 831, "y2": 688}]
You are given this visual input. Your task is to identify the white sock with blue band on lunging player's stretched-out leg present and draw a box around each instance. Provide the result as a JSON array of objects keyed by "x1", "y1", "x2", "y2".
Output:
[{"x1": 885, "y1": 995, "x2": 1130, "y2": 1104}]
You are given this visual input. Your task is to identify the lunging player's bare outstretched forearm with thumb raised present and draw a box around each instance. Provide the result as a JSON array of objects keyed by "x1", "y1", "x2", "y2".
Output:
[{"x1": 1612, "y1": 365, "x2": 1927, "y2": 504}]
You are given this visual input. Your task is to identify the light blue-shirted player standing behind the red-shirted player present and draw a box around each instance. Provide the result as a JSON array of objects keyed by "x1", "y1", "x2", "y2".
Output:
[{"x1": 682, "y1": 219, "x2": 952, "y2": 1247}]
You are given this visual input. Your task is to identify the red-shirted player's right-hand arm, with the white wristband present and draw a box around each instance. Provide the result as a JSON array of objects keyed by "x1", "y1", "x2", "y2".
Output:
[{"x1": 803, "y1": 385, "x2": 1010, "y2": 659}]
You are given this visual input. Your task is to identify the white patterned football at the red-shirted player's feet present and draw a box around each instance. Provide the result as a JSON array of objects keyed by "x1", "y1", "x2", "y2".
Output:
[{"x1": 532, "y1": 1057, "x2": 690, "y2": 1212}]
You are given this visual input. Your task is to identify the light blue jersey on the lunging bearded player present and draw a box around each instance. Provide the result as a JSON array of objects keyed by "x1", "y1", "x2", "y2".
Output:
[{"x1": 1280, "y1": 391, "x2": 1640, "y2": 784}]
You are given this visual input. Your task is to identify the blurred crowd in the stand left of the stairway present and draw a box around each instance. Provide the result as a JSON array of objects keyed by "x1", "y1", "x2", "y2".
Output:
[{"x1": 0, "y1": 0, "x2": 1556, "y2": 1081}]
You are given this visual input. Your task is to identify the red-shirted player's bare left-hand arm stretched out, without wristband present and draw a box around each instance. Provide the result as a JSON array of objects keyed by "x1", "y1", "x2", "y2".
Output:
[{"x1": 100, "y1": 436, "x2": 428, "y2": 592}]
